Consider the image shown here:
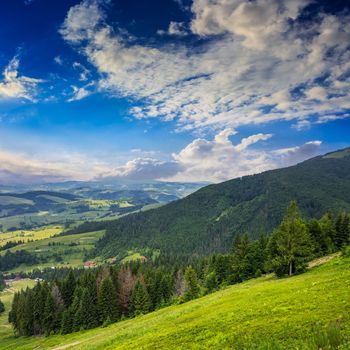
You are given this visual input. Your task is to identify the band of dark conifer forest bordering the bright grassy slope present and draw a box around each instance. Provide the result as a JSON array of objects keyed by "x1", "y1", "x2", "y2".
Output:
[{"x1": 9, "y1": 202, "x2": 350, "y2": 336}]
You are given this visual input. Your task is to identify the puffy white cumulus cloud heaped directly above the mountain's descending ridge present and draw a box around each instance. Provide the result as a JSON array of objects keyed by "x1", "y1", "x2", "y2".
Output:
[{"x1": 99, "y1": 128, "x2": 321, "y2": 182}]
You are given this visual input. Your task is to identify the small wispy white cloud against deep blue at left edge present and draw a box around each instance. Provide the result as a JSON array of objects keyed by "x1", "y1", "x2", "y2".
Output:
[{"x1": 0, "y1": 57, "x2": 43, "y2": 101}]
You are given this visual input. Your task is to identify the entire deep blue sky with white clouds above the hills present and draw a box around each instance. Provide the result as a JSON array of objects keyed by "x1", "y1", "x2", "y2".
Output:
[{"x1": 0, "y1": 0, "x2": 350, "y2": 184}]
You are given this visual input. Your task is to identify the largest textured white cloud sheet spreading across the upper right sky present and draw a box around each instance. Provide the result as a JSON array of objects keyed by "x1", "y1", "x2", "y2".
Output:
[{"x1": 61, "y1": 0, "x2": 350, "y2": 130}]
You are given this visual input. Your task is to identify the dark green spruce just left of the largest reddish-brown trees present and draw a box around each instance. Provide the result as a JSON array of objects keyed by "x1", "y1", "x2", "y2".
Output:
[{"x1": 98, "y1": 277, "x2": 119, "y2": 323}]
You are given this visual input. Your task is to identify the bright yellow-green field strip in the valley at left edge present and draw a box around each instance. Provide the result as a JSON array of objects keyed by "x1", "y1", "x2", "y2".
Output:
[{"x1": 0, "y1": 225, "x2": 63, "y2": 247}]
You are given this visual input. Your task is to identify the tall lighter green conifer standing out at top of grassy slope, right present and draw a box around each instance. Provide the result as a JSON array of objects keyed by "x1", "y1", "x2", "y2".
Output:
[{"x1": 269, "y1": 202, "x2": 312, "y2": 276}]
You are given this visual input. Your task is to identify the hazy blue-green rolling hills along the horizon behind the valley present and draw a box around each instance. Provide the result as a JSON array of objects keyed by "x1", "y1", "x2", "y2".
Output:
[{"x1": 0, "y1": 181, "x2": 204, "y2": 231}]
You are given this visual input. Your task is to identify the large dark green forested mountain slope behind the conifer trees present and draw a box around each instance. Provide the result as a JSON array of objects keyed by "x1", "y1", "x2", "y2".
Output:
[{"x1": 96, "y1": 148, "x2": 350, "y2": 257}]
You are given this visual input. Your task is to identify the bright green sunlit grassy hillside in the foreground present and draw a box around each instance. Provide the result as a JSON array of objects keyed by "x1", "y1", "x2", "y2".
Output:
[{"x1": 0, "y1": 257, "x2": 350, "y2": 350}]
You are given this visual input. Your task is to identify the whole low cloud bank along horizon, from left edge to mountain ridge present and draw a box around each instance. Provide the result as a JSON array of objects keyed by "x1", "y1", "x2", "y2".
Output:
[{"x1": 0, "y1": 128, "x2": 321, "y2": 184}]
